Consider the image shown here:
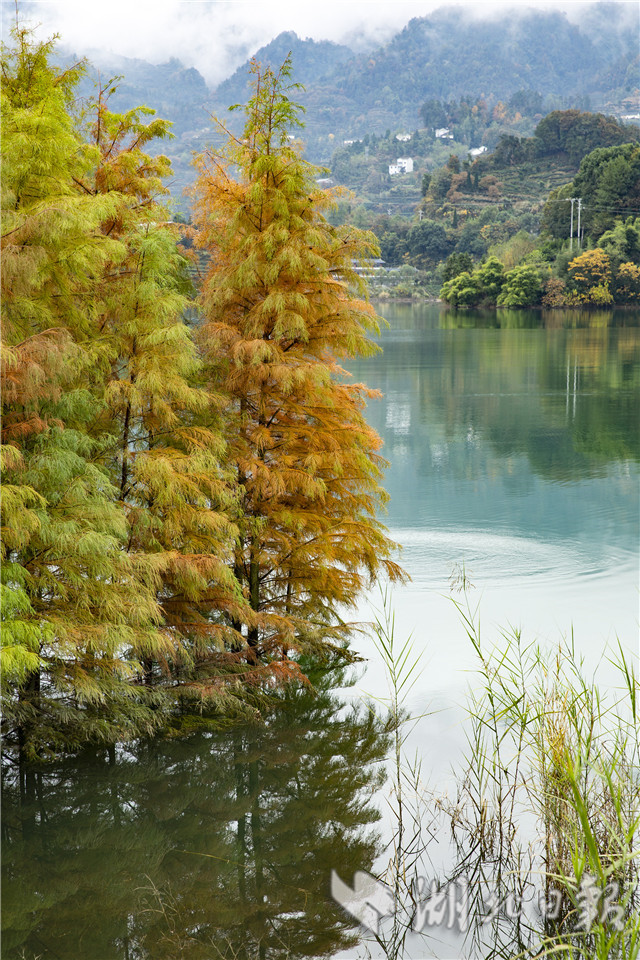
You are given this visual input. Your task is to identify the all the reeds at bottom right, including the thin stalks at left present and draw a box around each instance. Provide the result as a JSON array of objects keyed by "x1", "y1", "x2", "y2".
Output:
[{"x1": 364, "y1": 584, "x2": 640, "y2": 960}]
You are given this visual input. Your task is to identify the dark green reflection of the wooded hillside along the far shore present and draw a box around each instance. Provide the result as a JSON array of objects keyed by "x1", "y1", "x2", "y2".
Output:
[{"x1": 383, "y1": 311, "x2": 640, "y2": 472}]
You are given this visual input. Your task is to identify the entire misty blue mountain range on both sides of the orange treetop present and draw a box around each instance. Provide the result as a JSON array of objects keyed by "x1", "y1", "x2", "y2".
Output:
[{"x1": 47, "y1": 3, "x2": 639, "y2": 205}]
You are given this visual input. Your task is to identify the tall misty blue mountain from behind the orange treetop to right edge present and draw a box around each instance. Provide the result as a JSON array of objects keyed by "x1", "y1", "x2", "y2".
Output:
[{"x1": 209, "y1": 3, "x2": 638, "y2": 163}]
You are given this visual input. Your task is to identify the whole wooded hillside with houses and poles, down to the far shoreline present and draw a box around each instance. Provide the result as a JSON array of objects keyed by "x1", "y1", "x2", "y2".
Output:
[{"x1": 316, "y1": 107, "x2": 640, "y2": 306}]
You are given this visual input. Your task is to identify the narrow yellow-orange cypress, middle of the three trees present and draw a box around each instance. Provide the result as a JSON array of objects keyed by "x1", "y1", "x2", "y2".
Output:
[{"x1": 81, "y1": 91, "x2": 256, "y2": 711}]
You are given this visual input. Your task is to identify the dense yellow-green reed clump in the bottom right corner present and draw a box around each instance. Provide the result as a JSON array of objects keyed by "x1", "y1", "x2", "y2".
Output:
[{"x1": 442, "y1": 600, "x2": 640, "y2": 960}]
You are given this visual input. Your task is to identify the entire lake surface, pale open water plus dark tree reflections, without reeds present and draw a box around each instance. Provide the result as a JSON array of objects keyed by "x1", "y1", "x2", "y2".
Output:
[{"x1": 2, "y1": 304, "x2": 640, "y2": 960}]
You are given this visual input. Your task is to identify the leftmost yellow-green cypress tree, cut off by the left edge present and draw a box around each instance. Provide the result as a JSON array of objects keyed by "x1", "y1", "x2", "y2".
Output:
[{"x1": 2, "y1": 28, "x2": 166, "y2": 756}]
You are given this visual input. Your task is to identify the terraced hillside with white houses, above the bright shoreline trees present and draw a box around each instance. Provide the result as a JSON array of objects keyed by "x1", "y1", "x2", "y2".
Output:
[{"x1": 331, "y1": 110, "x2": 640, "y2": 255}]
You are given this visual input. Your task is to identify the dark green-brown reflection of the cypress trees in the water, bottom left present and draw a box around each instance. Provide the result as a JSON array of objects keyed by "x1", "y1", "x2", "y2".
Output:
[{"x1": 3, "y1": 677, "x2": 386, "y2": 960}]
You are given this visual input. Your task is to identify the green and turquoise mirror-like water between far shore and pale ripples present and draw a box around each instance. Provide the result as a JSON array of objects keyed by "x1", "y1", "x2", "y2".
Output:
[{"x1": 344, "y1": 304, "x2": 640, "y2": 552}]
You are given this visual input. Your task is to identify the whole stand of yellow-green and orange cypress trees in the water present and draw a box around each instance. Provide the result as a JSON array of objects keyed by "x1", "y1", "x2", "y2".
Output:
[{"x1": 2, "y1": 35, "x2": 401, "y2": 757}]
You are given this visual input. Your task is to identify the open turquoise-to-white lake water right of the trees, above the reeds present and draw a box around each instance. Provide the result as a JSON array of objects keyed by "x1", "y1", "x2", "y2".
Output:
[{"x1": 350, "y1": 304, "x2": 640, "y2": 700}]
